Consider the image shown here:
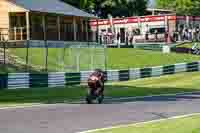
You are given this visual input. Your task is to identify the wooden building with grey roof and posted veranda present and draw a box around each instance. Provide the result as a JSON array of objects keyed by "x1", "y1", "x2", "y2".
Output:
[{"x1": 0, "y1": 0, "x2": 96, "y2": 45}]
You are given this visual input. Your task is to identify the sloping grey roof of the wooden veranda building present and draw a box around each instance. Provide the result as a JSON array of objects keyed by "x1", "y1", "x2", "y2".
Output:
[{"x1": 9, "y1": 0, "x2": 95, "y2": 17}]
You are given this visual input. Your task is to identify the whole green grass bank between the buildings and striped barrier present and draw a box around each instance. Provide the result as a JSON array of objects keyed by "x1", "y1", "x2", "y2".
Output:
[{"x1": 7, "y1": 48, "x2": 200, "y2": 71}]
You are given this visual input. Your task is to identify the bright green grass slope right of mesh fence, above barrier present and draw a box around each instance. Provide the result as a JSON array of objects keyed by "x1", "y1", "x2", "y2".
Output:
[{"x1": 107, "y1": 49, "x2": 200, "y2": 69}]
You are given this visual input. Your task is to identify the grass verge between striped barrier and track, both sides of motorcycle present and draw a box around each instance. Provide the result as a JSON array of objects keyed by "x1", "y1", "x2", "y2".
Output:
[{"x1": 0, "y1": 72, "x2": 200, "y2": 104}]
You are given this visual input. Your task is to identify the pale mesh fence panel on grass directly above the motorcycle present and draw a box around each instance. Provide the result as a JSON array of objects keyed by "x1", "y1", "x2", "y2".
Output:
[{"x1": 65, "y1": 48, "x2": 105, "y2": 71}]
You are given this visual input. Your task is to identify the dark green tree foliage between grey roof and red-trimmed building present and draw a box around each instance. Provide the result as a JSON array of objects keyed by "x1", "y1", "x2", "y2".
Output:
[{"x1": 63, "y1": 0, "x2": 148, "y2": 18}]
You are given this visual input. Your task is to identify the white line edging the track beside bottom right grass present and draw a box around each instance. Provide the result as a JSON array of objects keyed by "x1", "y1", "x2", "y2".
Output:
[{"x1": 78, "y1": 113, "x2": 200, "y2": 133}]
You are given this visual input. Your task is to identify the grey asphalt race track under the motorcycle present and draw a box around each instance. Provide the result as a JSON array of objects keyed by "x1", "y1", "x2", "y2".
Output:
[{"x1": 0, "y1": 93, "x2": 200, "y2": 133}]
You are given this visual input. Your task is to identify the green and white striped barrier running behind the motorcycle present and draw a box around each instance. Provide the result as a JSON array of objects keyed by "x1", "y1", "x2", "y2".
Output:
[{"x1": 0, "y1": 62, "x2": 200, "y2": 89}]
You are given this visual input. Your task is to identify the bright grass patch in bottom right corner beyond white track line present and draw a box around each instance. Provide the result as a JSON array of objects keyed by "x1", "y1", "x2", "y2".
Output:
[{"x1": 93, "y1": 115, "x2": 200, "y2": 133}]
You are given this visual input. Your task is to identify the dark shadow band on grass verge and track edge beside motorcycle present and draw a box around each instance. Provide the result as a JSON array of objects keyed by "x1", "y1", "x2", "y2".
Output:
[{"x1": 0, "y1": 85, "x2": 200, "y2": 104}]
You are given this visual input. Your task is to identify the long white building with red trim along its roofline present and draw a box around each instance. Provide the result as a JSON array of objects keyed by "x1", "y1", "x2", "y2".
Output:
[{"x1": 90, "y1": 15, "x2": 200, "y2": 43}]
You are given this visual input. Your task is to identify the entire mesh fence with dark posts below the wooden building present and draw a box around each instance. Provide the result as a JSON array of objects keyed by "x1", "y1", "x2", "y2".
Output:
[{"x1": 0, "y1": 48, "x2": 105, "y2": 72}]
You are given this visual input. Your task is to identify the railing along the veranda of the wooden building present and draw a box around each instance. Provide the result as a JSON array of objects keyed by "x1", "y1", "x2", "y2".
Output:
[{"x1": 0, "y1": 27, "x2": 96, "y2": 42}]
